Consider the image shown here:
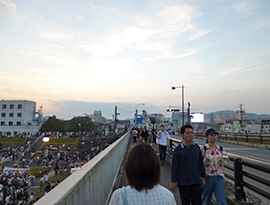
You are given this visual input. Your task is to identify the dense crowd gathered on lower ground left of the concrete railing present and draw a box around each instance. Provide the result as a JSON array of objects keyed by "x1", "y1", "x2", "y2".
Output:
[{"x1": 0, "y1": 132, "x2": 119, "y2": 205}]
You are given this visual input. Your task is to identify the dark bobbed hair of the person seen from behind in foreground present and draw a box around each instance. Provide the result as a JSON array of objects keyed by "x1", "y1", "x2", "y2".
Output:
[{"x1": 125, "y1": 143, "x2": 160, "y2": 191}]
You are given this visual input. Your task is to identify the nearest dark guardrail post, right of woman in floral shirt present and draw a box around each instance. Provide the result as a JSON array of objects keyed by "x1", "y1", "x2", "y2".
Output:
[{"x1": 234, "y1": 158, "x2": 246, "y2": 202}]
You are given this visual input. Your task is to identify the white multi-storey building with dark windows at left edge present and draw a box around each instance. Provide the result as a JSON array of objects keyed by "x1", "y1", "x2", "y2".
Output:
[{"x1": 0, "y1": 100, "x2": 41, "y2": 135}]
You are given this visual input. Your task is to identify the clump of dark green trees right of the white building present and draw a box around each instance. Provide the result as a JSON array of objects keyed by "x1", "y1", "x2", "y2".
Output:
[{"x1": 39, "y1": 115, "x2": 96, "y2": 132}]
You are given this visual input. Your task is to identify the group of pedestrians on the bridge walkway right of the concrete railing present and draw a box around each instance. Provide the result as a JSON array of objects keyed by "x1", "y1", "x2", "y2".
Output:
[{"x1": 115, "y1": 124, "x2": 229, "y2": 205}]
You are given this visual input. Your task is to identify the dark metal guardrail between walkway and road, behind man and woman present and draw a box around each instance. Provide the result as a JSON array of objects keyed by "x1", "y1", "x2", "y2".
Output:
[{"x1": 170, "y1": 138, "x2": 270, "y2": 202}]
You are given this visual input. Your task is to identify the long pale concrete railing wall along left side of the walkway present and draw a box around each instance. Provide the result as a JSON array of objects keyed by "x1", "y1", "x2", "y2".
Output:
[{"x1": 35, "y1": 132, "x2": 130, "y2": 205}]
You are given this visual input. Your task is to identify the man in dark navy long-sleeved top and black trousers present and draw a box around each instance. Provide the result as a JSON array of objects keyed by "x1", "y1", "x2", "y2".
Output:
[{"x1": 171, "y1": 125, "x2": 205, "y2": 205}]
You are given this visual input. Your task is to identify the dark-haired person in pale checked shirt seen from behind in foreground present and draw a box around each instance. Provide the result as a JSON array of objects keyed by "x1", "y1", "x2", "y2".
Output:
[{"x1": 109, "y1": 143, "x2": 176, "y2": 205}]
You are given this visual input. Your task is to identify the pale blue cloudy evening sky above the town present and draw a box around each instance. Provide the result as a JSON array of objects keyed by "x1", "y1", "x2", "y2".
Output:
[{"x1": 0, "y1": 0, "x2": 270, "y2": 119}]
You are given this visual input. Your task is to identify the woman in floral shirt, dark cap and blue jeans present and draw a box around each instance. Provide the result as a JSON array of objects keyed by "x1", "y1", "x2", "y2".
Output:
[{"x1": 201, "y1": 128, "x2": 229, "y2": 205}]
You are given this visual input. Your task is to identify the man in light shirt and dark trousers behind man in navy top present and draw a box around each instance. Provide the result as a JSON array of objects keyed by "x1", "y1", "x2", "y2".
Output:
[{"x1": 157, "y1": 125, "x2": 170, "y2": 165}]
